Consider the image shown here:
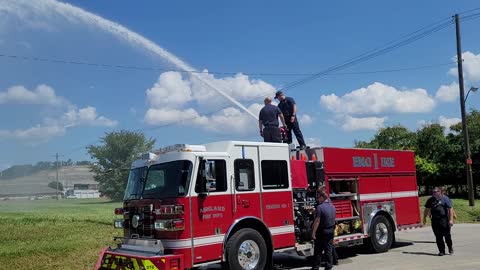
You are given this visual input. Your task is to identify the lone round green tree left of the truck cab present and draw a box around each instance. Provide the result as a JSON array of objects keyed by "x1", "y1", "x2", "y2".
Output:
[{"x1": 87, "y1": 130, "x2": 155, "y2": 200}]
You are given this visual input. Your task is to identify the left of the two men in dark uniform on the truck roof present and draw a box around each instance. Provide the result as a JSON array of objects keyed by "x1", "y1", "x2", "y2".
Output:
[{"x1": 258, "y1": 97, "x2": 285, "y2": 142}]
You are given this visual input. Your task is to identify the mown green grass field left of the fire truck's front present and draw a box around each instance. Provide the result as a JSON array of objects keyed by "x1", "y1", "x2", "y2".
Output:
[{"x1": 0, "y1": 199, "x2": 121, "y2": 269}]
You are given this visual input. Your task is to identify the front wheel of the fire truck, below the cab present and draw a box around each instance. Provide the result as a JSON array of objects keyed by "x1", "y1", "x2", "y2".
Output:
[{"x1": 226, "y1": 228, "x2": 267, "y2": 270}]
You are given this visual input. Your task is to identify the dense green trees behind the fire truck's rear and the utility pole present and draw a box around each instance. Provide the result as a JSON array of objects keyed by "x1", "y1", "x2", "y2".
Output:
[{"x1": 355, "y1": 110, "x2": 480, "y2": 194}]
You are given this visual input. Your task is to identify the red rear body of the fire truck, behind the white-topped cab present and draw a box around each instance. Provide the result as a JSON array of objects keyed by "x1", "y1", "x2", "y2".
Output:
[{"x1": 291, "y1": 147, "x2": 421, "y2": 252}]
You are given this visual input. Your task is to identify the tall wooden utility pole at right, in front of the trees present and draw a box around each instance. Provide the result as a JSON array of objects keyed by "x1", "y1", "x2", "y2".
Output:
[{"x1": 455, "y1": 14, "x2": 475, "y2": 206}]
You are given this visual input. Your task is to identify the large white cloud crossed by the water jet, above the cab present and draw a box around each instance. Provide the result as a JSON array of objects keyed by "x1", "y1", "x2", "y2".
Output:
[{"x1": 144, "y1": 72, "x2": 276, "y2": 134}]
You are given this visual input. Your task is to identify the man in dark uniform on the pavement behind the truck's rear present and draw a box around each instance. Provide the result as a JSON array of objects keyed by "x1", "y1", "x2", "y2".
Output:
[{"x1": 423, "y1": 187, "x2": 453, "y2": 256}]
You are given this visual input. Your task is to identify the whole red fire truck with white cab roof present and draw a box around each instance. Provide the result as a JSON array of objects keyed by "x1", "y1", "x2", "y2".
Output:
[{"x1": 96, "y1": 141, "x2": 421, "y2": 270}]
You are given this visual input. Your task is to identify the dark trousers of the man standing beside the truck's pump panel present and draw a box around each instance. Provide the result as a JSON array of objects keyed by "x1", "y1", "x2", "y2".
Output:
[{"x1": 313, "y1": 228, "x2": 334, "y2": 270}]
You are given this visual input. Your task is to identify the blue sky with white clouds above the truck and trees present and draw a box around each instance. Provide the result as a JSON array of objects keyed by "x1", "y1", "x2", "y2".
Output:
[{"x1": 0, "y1": 0, "x2": 480, "y2": 169}]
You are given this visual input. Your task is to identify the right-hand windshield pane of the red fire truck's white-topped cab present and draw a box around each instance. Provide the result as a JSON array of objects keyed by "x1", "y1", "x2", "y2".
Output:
[{"x1": 143, "y1": 160, "x2": 192, "y2": 199}]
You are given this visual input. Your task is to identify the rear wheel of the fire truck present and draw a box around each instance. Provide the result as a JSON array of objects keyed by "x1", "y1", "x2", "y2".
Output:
[{"x1": 369, "y1": 215, "x2": 393, "y2": 253}]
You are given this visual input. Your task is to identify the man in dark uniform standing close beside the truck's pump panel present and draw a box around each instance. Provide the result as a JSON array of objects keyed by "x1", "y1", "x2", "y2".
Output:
[{"x1": 312, "y1": 190, "x2": 336, "y2": 270}]
